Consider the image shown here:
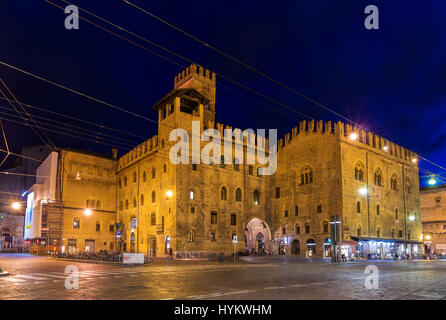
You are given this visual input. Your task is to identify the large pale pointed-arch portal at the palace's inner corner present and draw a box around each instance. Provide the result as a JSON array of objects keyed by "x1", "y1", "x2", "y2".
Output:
[{"x1": 244, "y1": 218, "x2": 272, "y2": 254}]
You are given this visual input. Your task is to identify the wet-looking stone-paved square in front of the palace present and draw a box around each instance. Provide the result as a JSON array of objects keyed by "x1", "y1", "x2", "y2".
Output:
[{"x1": 0, "y1": 254, "x2": 446, "y2": 300}]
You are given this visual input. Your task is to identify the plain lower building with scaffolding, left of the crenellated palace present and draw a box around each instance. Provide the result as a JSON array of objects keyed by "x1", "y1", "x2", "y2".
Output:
[{"x1": 25, "y1": 149, "x2": 117, "y2": 253}]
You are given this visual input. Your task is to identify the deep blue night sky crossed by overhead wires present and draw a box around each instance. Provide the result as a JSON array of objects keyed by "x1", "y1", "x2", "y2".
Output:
[{"x1": 0, "y1": 0, "x2": 446, "y2": 185}]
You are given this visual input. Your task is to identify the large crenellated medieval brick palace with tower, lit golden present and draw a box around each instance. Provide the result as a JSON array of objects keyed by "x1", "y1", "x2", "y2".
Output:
[{"x1": 117, "y1": 65, "x2": 421, "y2": 259}]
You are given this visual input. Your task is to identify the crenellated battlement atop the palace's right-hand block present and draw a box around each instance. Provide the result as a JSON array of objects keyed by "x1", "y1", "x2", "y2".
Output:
[{"x1": 278, "y1": 120, "x2": 418, "y2": 165}]
